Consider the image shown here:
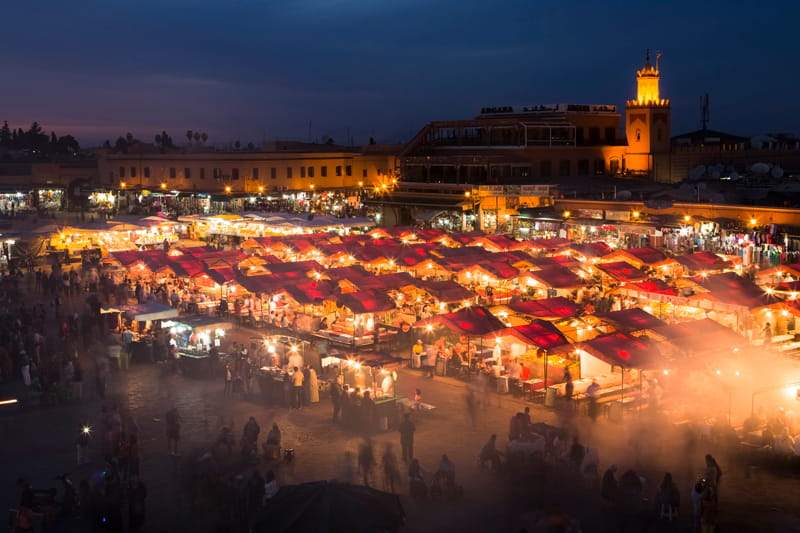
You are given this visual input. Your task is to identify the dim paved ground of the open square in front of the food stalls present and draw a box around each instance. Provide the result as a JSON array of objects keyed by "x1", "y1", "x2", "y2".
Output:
[{"x1": 0, "y1": 322, "x2": 800, "y2": 532}]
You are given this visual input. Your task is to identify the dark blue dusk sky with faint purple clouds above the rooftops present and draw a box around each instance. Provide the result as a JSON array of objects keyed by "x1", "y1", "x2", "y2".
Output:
[{"x1": 0, "y1": 0, "x2": 800, "y2": 145}]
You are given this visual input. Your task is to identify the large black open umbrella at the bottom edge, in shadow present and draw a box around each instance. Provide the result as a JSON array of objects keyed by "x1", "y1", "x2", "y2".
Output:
[{"x1": 250, "y1": 481, "x2": 405, "y2": 533}]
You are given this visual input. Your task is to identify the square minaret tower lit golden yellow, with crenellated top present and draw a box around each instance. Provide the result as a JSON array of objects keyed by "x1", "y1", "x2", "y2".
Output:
[{"x1": 625, "y1": 50, "x2": 671, "y2": 181}]
